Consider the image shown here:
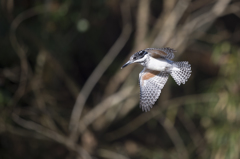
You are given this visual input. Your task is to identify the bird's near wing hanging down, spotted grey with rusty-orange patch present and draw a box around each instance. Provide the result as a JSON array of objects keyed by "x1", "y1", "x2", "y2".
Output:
[{"x1": 139, "y1": 68, "x2": 169, "y2": 112}]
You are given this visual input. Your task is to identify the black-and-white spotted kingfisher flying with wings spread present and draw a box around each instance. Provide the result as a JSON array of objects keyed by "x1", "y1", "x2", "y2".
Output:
[{"x1": 121, "y1": 47, "x2": 192, "y2": 112}]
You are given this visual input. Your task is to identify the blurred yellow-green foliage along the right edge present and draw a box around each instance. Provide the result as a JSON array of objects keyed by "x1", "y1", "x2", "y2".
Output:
[{"x1": 194, "y1": 42, "x2": 240, "y2": 159}]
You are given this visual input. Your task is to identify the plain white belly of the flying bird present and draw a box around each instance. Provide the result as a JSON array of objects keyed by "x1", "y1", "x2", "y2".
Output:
[{"x1": 146, "y1": 59, "x2": 172, "y2": 71}]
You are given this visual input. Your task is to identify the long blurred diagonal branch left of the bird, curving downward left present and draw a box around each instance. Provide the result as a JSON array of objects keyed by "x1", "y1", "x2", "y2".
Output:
[{"x1": 69, "y1": 0, "x2": 132, "y2": 136}]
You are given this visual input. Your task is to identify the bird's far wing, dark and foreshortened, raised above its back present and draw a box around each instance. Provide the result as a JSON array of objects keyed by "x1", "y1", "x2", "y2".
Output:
[{"x1": 145, "y1": 47, "x2": 176, "y2": 59}]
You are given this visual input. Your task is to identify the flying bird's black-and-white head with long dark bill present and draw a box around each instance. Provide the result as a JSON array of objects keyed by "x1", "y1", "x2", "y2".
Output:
[{"x1": 121, "y1": 50, "x2": 148, "y2": 69}]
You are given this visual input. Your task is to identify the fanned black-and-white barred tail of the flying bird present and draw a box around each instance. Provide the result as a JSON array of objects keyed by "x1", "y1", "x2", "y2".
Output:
[{"x1": 171, "y1": 61, "x2": 192, "y2": 86}]
